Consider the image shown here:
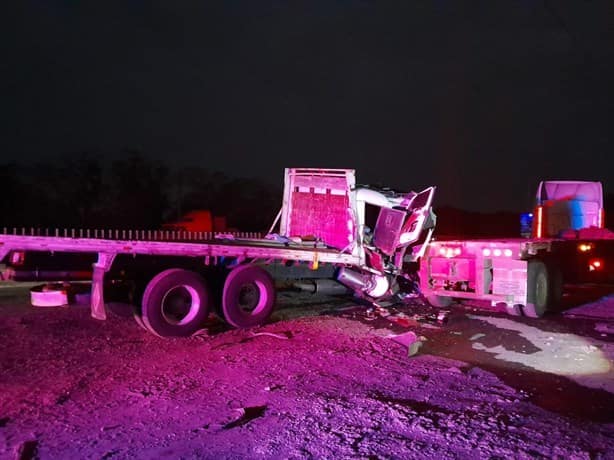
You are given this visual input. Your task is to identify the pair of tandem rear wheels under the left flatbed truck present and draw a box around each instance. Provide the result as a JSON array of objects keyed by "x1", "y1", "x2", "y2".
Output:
[{"x1": 137, "y1": 265, "x2": 275, "y2": 337}]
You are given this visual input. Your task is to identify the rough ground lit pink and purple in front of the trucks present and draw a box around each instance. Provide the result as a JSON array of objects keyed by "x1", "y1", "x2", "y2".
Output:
[{"x1": 0, "y1": 284, "x2": 614, "y2": 459}]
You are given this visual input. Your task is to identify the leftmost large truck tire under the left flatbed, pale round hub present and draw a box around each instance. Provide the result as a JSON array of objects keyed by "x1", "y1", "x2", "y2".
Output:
[{"x1": 141, "y1": 268, "x2": 211, "y2": 337}]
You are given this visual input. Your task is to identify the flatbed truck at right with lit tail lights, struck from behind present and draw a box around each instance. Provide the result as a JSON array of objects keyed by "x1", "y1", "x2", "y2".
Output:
[{"x1": 419, "y1": 181, "x2": 614, "y2": 317}]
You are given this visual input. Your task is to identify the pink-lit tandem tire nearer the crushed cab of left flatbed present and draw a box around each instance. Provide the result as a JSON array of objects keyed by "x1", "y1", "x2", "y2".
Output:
[{"x1": 222, "y1": 265, "x2": 276, "y2": 329}]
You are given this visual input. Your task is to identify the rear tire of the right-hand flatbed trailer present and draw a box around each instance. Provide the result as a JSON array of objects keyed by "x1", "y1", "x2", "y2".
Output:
[{"x1": 523, "y1": 260, "x2": 563, "y2": 318}]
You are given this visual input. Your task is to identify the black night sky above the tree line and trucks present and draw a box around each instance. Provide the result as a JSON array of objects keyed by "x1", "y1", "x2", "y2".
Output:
[{"x1": 0, "y1": 0, "x2": 614, "y2": 211}]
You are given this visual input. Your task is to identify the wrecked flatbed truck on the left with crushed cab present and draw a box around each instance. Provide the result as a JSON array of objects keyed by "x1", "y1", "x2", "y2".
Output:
[{"x1": 0, "y1": 168, "x2": 435, "y2": 336}]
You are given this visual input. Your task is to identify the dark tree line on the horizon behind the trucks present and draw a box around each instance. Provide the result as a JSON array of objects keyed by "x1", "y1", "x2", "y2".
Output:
[{"x1": 0, "y1": 151, "x2": 614, "y2": 237}]
